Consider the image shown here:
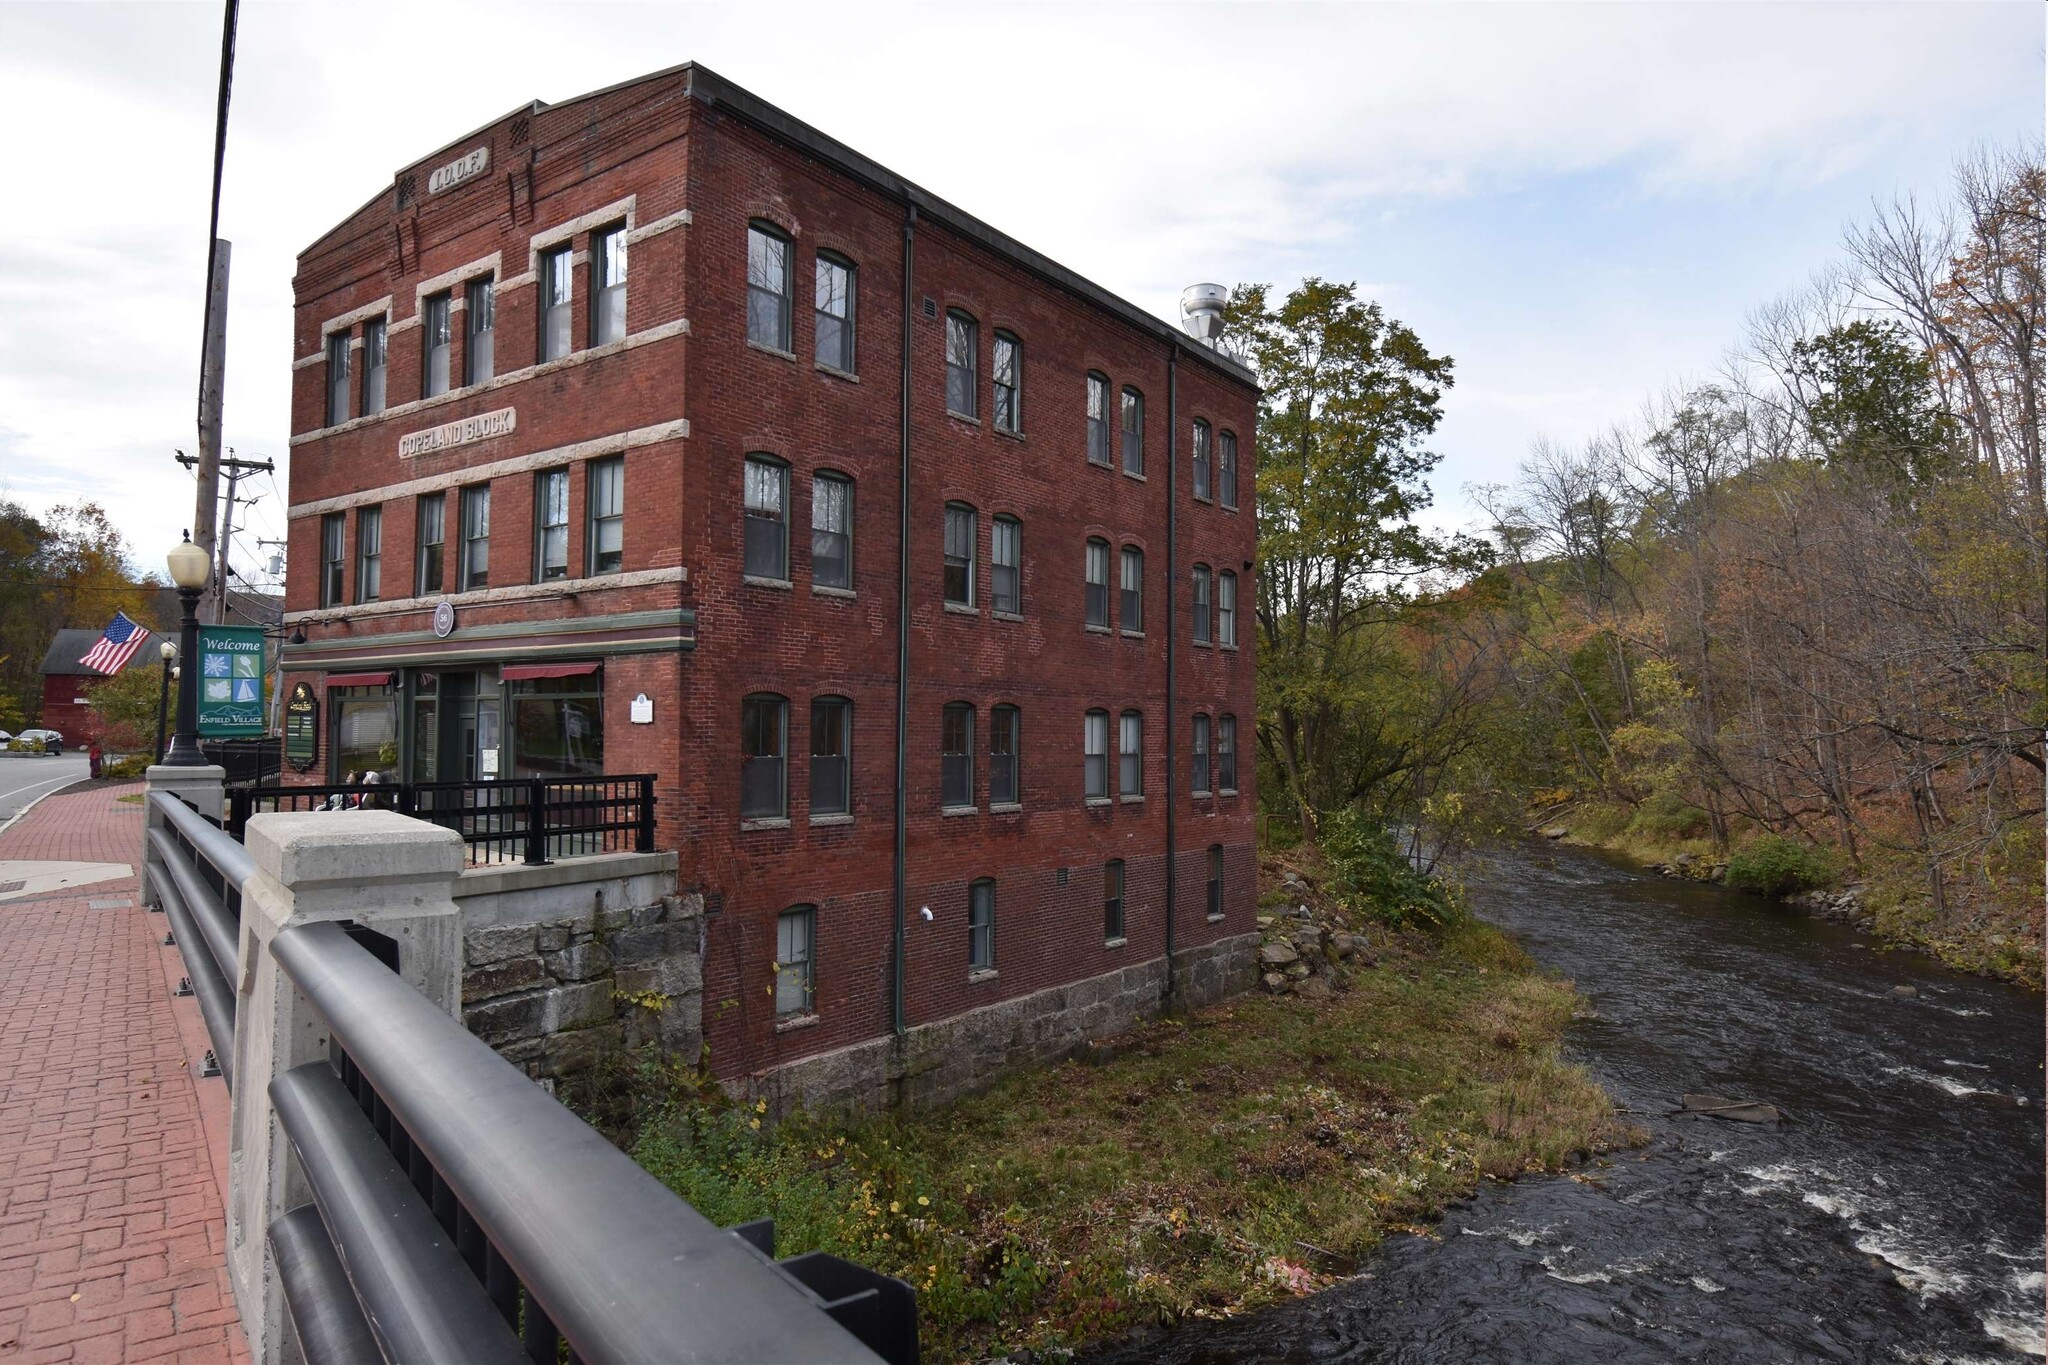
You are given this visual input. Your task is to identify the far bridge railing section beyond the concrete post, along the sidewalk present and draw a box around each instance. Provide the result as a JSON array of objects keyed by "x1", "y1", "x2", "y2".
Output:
[{"x1": 143, "y1": 792, "x2": 256, "y2": 1087}]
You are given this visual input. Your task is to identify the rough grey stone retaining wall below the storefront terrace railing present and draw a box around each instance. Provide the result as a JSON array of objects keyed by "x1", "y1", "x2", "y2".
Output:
[{"x1": 455, "y1": 853, "x2": 702, "y2": 1083}]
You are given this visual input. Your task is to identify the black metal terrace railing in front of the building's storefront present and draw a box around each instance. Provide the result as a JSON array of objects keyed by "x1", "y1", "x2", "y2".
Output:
[{"x1": 227, "y1": 774, "x2": 653, "y2": 866}]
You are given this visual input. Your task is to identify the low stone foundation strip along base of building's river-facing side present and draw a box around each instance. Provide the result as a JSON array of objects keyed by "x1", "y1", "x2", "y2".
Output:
[{"x1": 731, "y1": 933, "x2": 1260, "y2": 1113}]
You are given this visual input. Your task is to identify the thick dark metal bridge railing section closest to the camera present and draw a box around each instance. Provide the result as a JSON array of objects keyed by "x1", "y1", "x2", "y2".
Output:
[{"x1": 268, "y1": 923, "x2": 918, "y2": 1365}]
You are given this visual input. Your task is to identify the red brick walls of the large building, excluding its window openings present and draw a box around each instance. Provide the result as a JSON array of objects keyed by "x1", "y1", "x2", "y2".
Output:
[{"x1": 285, "y1": 68, "x2": 1257, "y2": 1078}]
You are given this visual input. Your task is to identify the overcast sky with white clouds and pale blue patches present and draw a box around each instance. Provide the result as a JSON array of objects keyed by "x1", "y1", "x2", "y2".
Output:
[{"x1": 0, "y1": 0, "x2": 2048, "y2": 593}]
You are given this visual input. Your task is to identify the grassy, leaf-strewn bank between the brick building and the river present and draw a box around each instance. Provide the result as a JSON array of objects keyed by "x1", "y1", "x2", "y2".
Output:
[{"x1": 633, "y1": 892, "x2": 1626, "y2": 1361}]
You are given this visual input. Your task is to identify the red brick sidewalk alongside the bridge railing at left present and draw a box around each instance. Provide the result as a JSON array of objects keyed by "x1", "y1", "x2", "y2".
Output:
[{"x1": 0, "y1": 784, "x2": 248, "y2": 1365}]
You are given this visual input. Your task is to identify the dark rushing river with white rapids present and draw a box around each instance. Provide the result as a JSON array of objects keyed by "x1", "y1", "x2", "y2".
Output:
[{"x1": 1090, "y1": 847, "x2": 2048, "y2": 1365}]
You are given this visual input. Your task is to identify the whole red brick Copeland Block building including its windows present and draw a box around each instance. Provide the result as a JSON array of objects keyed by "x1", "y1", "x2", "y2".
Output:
[{"x1": 285, "y1": 65, "x2": 1257, "y2": 1076}]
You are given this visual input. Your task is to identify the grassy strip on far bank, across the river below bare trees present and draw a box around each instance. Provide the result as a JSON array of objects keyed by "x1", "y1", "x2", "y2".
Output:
[{"x1": 1532, "y1": 802, "x2": 2044, "y2": 990}]
